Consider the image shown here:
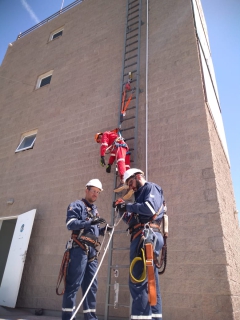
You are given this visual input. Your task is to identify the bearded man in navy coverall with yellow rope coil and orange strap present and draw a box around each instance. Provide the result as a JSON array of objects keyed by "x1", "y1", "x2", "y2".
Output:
[{"x1": 113, "y1": 169, "x2": 164, "y2": 320}]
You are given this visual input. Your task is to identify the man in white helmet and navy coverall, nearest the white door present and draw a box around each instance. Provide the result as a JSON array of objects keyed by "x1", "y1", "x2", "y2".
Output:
[{"x1": 62, "y1": 179, "x2": 106, "y2": 320}]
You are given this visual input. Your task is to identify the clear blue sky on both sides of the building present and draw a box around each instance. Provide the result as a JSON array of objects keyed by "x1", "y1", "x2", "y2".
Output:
[{"x1": 0, "y1": 0, "x2": 240, "y2": 220}]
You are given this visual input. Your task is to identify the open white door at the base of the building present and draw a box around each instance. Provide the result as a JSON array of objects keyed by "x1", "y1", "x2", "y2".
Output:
[{"x1": 0, "y1": 209, "x2": 36, "y2": 308}]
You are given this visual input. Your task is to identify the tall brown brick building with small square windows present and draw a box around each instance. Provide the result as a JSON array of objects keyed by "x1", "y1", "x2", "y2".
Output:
[{"x1": 0, "y1": 0, "x2": 240, "y2": 320}]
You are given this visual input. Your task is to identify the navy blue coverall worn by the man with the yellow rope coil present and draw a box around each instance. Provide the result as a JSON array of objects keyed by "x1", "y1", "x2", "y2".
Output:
[{"x1": 123, "y1": 182, "x2": 164, "y2": 320}]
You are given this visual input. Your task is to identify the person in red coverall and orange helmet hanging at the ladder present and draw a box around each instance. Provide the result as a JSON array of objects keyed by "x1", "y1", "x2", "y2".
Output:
[{"x1": 95, "y1": 130, "x2": 130, "y2": 192}]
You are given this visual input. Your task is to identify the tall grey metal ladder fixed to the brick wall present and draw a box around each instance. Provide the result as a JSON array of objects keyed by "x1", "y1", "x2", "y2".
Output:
[{"x1": 104, "y1": 0, "x2": 142, "y2": 320}]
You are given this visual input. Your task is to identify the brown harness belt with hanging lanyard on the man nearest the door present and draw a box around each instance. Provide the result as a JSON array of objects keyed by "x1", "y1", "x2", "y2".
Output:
[{"x1": 56, "y1": 233, "x2": 100, "y2": 296}]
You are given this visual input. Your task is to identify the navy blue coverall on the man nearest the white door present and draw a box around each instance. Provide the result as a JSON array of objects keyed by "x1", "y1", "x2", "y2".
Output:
[{"x1": 62, "y1": 199, "x2": 105, "y2": 320}]
